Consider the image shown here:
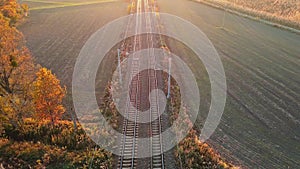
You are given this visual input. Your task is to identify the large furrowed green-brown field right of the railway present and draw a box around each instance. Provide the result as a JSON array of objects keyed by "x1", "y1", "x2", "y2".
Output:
[{"x1": 159, "y1": 0, "x2": 300, "y2": 168}]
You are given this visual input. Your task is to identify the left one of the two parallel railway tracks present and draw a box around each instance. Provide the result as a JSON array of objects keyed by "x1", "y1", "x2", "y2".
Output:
[{"x1": 118, "y1": 0, "x2": 141, "y2": 169}]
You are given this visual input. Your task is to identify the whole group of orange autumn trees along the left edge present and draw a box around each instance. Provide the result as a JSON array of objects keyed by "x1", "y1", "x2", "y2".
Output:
[{"x1": 0, "y1": 0, "x2": 66, "y2": 134}]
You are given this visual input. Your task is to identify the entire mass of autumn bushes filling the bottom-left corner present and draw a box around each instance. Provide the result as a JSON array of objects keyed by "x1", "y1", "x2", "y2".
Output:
[{"x1": 0, "y1": 118, "x2": 112, "y2": 168}]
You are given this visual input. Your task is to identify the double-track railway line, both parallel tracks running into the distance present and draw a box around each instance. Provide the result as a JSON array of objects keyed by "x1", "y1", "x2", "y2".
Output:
[{"x1": 118, "y1": 0, "x2": 164, "y2": 169}]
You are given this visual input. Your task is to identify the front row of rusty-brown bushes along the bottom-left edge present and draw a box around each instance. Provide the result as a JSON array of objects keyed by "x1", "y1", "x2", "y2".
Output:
[{"x1": 0, "y1": 139, "x2": 112, "y2": 168}]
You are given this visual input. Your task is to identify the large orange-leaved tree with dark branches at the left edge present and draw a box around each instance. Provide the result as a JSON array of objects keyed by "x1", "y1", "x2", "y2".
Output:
[{"x1": 0, "y1": 13, "x2": 35, "y2": 130}]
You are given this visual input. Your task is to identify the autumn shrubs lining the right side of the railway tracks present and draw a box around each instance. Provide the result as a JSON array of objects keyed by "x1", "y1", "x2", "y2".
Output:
[{"x1": 165, "y1": 60, "x2": 238, "y2": 169}]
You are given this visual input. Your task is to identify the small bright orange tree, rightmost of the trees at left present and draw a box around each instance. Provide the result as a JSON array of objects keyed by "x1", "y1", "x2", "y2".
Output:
[{"x1": 33, "y1": 68, "x2": 66, "y2": 125}]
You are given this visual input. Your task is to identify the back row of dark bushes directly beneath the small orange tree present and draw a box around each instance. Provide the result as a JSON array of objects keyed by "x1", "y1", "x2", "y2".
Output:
[{"x1": 2, "y1": 118, "x2": 95, "y2": 150}]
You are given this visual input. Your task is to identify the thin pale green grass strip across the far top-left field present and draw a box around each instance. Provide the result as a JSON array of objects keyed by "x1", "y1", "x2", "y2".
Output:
[{"x1": 29, "y1": 0, "x2": 118, "y2": 11}]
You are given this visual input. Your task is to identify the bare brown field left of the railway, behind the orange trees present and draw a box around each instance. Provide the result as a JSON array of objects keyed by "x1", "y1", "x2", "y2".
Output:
[{"x1": 19, "y1": 1, "x2": 128, "y2": 117}]
